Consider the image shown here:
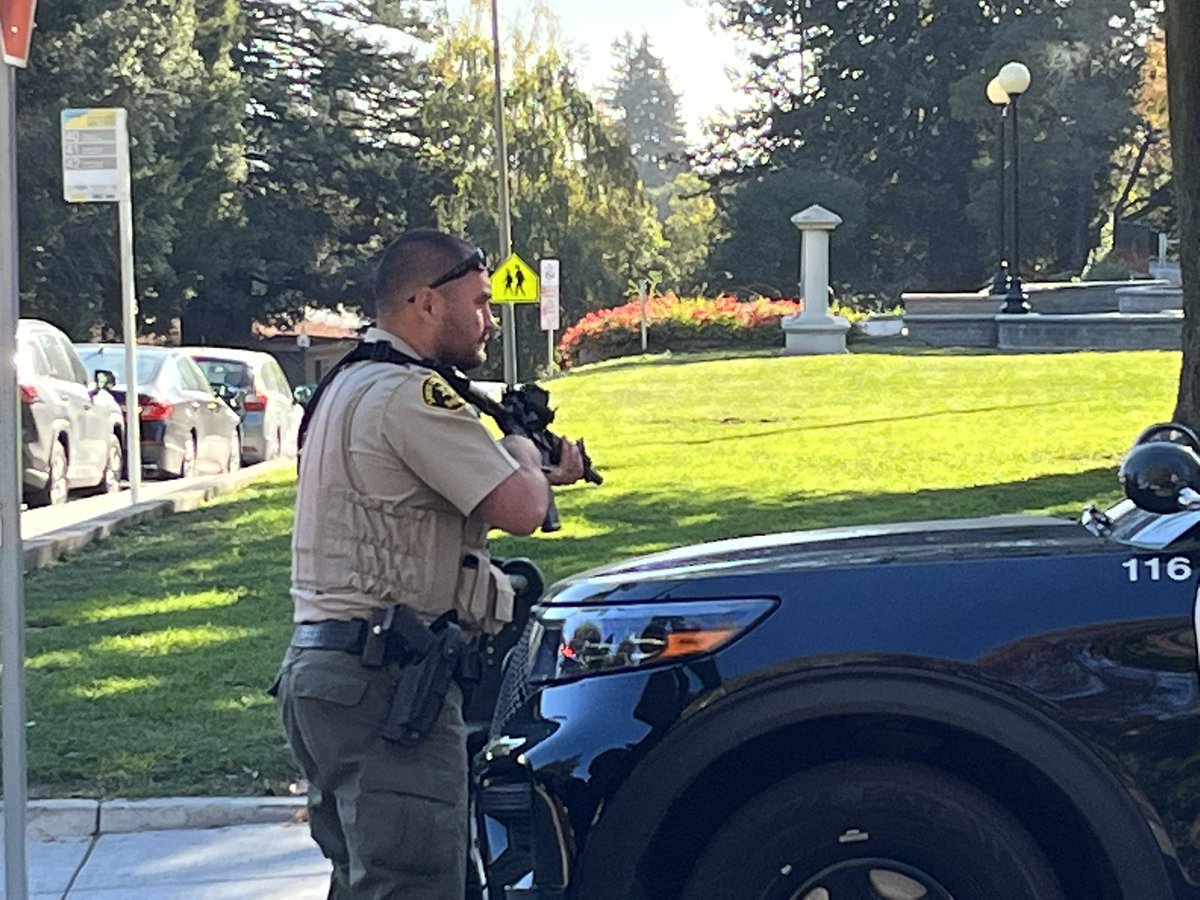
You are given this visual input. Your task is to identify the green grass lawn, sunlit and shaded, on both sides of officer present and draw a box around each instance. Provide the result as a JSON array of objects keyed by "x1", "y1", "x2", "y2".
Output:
[{"x1": 18, "y1": 348, "x2": 1180, "y2": 798}]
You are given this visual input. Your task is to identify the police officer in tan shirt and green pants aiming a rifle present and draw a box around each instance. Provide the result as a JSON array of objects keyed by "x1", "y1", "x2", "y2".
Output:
[{"x1": 275, "y1": 230, "x2": 583, "y2": 900}]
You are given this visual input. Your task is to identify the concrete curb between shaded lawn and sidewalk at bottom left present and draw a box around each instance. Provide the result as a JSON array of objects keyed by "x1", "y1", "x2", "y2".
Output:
[{"x1": 0, "y1": 797, "x2": 307, "y2": 841}]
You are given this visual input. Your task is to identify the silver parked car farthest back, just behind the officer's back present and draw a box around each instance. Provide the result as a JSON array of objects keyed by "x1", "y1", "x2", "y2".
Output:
[{"x1": 181, "y1": 347, "x2": 304, "y2": 463}]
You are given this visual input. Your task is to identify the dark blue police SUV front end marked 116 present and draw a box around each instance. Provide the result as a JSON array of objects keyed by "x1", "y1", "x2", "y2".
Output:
[{"x1": 473, "y1": 426, "x2": 1200, "y2": 900}]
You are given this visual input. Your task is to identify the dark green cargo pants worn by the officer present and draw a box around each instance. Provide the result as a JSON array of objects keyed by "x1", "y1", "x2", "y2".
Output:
[{"x1": 276, "y1": 648, "x2": 467, "y2": 900}]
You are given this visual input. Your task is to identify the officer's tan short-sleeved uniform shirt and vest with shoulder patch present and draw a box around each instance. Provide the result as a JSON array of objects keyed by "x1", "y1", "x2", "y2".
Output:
[{"x1": 292, "y1": 329, "x2": 518, "y2": 622}]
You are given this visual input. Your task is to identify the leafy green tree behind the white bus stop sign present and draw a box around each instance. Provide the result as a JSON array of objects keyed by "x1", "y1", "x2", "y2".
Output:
[{"x1": 17, "y1": 0, "x2": 241, "y2": 337}]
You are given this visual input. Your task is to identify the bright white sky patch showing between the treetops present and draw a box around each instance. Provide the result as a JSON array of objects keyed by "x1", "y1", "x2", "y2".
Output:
[{"x1": 451, "y1": 0, "x2": 737, "y2": 140}]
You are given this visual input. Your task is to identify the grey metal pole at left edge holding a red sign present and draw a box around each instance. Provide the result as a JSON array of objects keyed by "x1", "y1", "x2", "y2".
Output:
[{"x1": 0, "y1": 64, "x2": 29, "y2": 900}]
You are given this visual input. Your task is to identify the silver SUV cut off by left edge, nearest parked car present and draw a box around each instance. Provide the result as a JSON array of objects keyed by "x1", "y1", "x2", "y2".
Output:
[{"x1": 17, "y1": 319, "x2": 125, "y2": 506}]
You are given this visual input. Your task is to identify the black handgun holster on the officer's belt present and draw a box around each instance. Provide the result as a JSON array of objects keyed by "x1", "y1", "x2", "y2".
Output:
[{"x1": 362, "y1": 605, "x2": 480, "y2": 744}]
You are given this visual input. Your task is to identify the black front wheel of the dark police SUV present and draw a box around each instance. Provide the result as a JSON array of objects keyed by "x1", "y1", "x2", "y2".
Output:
[{"x1": 683, "y1": 760, "x2": 1062, "y2": 900}]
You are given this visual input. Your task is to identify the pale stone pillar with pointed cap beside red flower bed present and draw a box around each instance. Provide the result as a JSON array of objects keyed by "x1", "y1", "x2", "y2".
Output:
[{"x1": 780, "y1": 204, "x2": 850, "y2": 356}]
